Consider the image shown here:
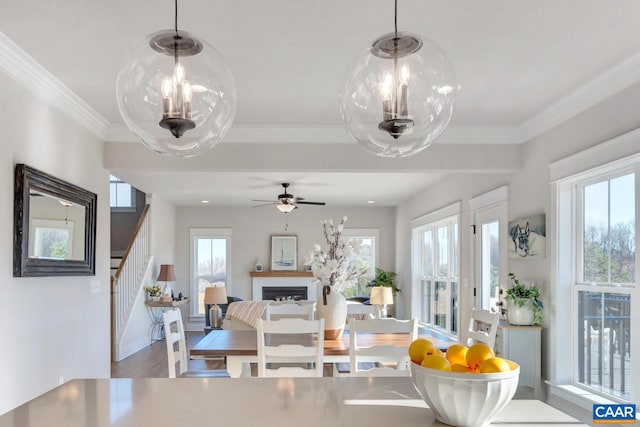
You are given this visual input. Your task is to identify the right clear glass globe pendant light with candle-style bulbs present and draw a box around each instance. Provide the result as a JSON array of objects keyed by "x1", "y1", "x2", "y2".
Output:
[{"x1": 340, "y1": 0, "x2": 457, "y2": 157}]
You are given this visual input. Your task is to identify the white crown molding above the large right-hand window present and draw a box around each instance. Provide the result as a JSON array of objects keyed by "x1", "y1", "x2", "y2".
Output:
[{"x1": 520, "y1": 53, "x2": 640, "y2": 141}]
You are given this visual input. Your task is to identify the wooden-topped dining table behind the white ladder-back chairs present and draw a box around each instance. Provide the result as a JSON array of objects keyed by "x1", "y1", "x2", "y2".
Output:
[{"x1": 189, "y1": 329, "x2": 457, "y2": 378}]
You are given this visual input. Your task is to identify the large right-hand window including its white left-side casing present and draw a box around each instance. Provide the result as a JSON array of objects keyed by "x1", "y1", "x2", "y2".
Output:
[{"x1": 557, "y1": 166, "x2": 640, "y2": 401}]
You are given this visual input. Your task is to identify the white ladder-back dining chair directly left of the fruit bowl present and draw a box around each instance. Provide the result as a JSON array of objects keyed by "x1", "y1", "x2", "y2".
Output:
[{"x1": 349, "y1": 318, "x2": 418, "y2": 376}]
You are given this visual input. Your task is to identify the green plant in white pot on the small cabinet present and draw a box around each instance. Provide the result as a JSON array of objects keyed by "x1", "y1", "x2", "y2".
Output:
[{"x1": 505, "y1": 273, "x2": 543, "y2": 325}]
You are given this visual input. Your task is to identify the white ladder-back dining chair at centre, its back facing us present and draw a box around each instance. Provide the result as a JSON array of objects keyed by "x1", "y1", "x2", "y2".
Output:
[{"x1": 256, "y1": 319, "x2": 324, "y2": 377}]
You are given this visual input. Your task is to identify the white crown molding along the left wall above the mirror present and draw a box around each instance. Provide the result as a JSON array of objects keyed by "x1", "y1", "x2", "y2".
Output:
[{"x1": 0, "y1": 31, "x2": 109, "y2": 139}]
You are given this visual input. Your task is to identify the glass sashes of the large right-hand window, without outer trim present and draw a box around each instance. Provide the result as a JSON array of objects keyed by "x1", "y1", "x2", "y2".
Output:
[{"x1": 574, "y1": 171, "x2": 636, "y2": 400}]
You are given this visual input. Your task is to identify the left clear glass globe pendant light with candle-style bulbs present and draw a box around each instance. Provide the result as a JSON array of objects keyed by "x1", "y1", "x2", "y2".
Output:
[{"x1": 116, "y1": 0, "x2": 237, "y2": 157}]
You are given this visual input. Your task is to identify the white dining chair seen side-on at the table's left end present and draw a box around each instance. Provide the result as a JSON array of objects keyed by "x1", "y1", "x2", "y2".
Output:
[{"x1": 162, "y1": 309, "x2": 229, "y2": 378}]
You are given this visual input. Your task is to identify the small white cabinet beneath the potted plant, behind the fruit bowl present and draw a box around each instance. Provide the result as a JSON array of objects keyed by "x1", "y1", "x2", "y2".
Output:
[{"x1": 495, "y1": 323, "x2": 542, "y2": 399}]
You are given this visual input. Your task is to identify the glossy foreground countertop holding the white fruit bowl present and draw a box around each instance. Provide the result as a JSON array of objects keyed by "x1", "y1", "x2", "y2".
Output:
[{"x1": 0, "y1": 377, "x2": 586, "y2": 427}]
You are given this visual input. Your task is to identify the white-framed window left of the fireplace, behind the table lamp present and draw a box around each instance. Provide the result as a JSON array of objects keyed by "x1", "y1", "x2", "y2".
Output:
[{"x1": 190, "y1": 228, "x2": 231, "y2": 316}]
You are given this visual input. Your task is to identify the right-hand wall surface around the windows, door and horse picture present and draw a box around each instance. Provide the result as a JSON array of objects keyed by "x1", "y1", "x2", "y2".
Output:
[{"x1": 396, "y1": 85, "x2": 640, "y2": 390}]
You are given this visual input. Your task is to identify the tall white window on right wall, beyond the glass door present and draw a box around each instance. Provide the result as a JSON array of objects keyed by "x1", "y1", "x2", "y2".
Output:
[{"x1": 412, "y1": 205, "x2": 460, "y2": 335}]
